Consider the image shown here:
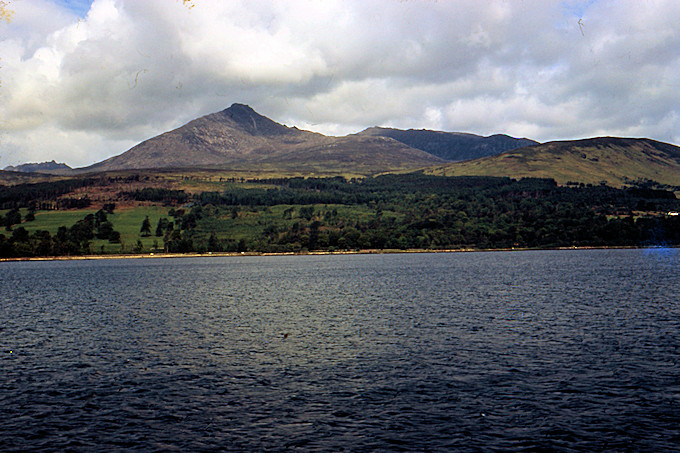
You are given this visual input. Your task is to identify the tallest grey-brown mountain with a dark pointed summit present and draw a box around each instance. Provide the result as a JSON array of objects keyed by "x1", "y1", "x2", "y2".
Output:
[{"x1": 78, "y1": 104, "x2": 442, "y2": 174}]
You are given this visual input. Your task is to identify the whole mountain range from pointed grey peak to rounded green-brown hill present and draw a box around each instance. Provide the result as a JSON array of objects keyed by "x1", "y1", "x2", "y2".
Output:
[{"x1": 41, "y1": 104, "x2": 680, "y2": 186}]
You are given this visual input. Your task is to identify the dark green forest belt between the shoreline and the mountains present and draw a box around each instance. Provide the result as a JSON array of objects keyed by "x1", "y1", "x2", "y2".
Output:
[{"x1": 0, "y1": 173, "x2": 680, "y2": 258}]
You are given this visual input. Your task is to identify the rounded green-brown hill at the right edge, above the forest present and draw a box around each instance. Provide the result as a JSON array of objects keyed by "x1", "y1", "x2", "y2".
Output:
[{"x1": 426, "y1": 137, "x2": 680, "y2": 186}]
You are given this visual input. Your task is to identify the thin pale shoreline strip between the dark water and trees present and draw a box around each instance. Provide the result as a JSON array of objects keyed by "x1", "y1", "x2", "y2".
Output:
[{"x1": 0, "y1": 246, "x2": 678, "y2": 262}]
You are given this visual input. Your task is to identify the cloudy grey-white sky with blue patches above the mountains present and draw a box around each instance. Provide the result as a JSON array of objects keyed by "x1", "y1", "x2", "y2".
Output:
[{"x1": 0, "y1": 0, "x2": 680, "y2": 168}]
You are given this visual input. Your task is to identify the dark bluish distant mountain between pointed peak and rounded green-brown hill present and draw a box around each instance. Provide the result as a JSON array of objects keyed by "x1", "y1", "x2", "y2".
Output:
[{"x1": 358, "y1": 127, "x2": 538, "y2": 161}]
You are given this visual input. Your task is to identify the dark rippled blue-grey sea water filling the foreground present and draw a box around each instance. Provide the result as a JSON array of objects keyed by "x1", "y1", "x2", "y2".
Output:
[{"x1": 0, "y1": 249, "x2": 680, "y2": 452}]
